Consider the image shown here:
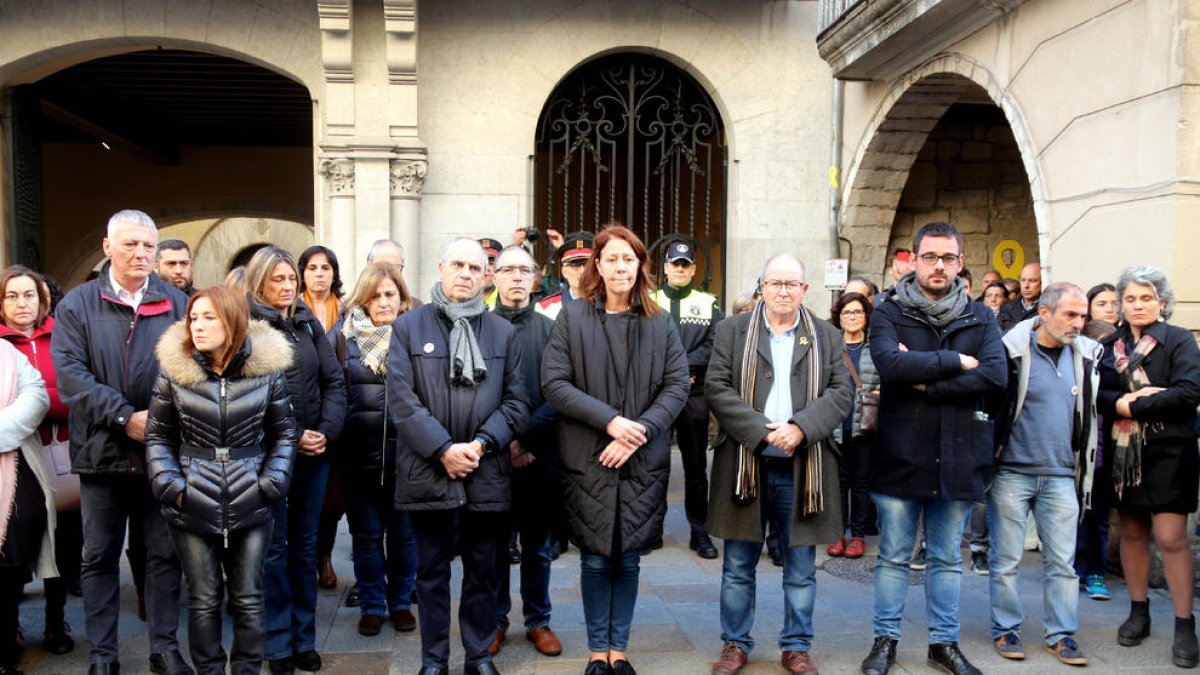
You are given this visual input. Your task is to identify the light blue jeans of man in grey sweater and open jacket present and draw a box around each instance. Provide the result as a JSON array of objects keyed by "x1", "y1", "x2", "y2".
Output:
[{"x1": 988, "y1": 470, "x2": 1079, "y2": 645}]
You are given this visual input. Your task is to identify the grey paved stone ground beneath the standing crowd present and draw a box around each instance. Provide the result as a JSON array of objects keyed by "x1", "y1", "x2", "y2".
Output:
[{"x1": 20, "y1": 449, "x2": 1195, "y2": 675}]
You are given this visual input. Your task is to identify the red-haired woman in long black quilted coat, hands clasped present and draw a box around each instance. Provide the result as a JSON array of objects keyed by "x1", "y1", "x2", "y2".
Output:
[{"x1": 541, "y1": 225, "x2": 689, "y2": 675}]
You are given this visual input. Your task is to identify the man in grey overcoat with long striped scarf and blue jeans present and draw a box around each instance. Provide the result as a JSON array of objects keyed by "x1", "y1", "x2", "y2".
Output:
[{"x1": 704, "y1": 255, "x2": 854, "y2": 675}]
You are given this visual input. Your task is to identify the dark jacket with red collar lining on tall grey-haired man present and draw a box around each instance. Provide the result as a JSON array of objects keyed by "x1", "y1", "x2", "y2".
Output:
[{"x1": 50, "y1": 263, "x2": 187, "y2": 473}]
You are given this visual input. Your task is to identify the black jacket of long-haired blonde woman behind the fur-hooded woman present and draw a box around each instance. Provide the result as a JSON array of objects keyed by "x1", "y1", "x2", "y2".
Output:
[{"x1": 250, "y1": 297, "x2": 346, "y2": 451}]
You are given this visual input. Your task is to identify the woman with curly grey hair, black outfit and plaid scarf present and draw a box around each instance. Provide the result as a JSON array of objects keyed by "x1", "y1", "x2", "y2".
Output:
[{"x1": 1097, "y1": 267, "x2": 1200, "y2": 668}]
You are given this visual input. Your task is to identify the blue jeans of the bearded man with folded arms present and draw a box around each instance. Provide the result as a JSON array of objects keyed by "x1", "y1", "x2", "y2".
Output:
[{"x1": 871, "y1": 492, "x2": 971, "y2": 645}]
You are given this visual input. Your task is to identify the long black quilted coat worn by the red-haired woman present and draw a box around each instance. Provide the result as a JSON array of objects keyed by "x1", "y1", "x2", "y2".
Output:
[{"x1": 541, "y1": 300, "x2": 690, "y2": 555}]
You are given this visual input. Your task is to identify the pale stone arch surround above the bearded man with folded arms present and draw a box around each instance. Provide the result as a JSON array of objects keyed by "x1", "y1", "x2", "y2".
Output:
[{"x1": 839, "y1": 54, "x2": 1050, "y2": 281}]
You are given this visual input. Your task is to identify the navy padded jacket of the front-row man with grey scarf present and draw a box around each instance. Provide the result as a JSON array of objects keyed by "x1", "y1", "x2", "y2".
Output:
[{"x1": 388, "y1": 304, "x2": 529, "y2": 512}]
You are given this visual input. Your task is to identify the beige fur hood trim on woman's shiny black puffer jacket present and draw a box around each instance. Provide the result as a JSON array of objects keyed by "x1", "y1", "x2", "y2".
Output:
[{"x1": 155, "y1": 318, "x2": 295, "y2": 387}]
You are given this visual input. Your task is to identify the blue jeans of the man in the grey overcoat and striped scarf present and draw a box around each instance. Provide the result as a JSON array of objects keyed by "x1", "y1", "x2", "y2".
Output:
[{"x1": 721, "y1": 462, "x2": 817, "y2": 653}]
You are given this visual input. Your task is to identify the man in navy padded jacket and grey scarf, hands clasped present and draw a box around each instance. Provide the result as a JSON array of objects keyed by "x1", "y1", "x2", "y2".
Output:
[{"x1": 388, "y1": 239, "x2": 529, "y2": 675}]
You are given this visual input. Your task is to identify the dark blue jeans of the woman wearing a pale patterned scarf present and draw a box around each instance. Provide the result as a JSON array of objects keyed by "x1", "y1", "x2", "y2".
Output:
[{"x1": 342, "y1": 470, "x2": 416, "y2": 616}]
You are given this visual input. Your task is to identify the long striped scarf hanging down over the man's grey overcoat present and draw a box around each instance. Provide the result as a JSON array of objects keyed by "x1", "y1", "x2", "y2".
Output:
[{"x1": 733, "y1": 300, "x2": 824, "y2": 518}]
